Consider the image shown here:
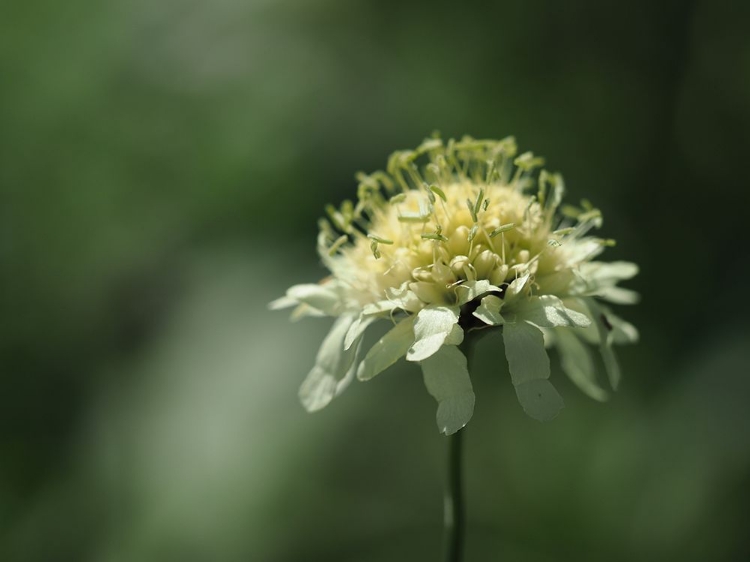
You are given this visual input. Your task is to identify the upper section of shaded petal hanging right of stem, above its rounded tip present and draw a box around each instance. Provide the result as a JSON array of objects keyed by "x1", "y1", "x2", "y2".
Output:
[{"x1": 503, "y1": 322, "x2": 549, "y2": 385}]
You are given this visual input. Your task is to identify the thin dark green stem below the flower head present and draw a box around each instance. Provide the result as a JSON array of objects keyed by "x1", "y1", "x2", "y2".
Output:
[{"x1": 443, "y1": 429, "x2": 465, "y2": 562}]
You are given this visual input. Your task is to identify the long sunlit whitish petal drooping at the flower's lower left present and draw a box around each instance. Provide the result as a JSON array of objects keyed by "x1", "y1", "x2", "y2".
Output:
[{"x1": 299, "y1": 315, "x2": 361, "y2": 412}]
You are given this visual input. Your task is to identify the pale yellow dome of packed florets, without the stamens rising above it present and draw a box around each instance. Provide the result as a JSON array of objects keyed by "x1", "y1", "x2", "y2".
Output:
[{"x1": 332, "y1": 180, "x2": 560, "y2": 304}]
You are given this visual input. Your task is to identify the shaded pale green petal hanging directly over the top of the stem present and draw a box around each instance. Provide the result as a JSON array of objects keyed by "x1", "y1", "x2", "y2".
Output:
[{"x1": 422, "y1": 346, "x2": 474, "y2": 435}]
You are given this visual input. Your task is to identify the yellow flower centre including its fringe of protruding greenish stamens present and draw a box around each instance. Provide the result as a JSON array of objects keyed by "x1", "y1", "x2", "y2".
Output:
[{"x1": 321, "y1": 139, "x2": 599, "y2": 305}]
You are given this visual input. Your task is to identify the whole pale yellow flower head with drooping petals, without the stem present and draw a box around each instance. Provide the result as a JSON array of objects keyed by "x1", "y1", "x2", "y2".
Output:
[{"x1": 271, "y1": 137, "x2": 638, "y2": 434}]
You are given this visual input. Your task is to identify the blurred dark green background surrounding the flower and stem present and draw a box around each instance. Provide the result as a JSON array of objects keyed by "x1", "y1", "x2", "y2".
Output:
[{"x1": 0, "y1": 0, "x2": 750, "y2": 562}]
